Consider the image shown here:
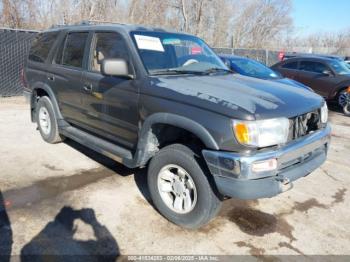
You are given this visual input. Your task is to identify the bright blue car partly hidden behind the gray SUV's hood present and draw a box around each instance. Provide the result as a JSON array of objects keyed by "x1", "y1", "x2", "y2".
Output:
[{"x1": 219, "y1": 54, "x2": 312, "y2": 91}]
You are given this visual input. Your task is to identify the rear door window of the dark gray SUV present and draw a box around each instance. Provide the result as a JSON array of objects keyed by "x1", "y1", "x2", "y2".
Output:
[{"x1": 62, "y1": 32, "x2": 89, "y2": 68}]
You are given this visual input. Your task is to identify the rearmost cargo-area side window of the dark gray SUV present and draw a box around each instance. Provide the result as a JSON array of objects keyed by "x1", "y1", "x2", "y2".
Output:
[{"x1": 29, "y1": 32, "x2": 59, "y2": 63}]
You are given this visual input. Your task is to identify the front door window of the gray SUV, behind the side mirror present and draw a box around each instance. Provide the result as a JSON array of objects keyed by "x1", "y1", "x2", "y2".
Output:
[{"x1": 90, "y1": 33, "x2": 130, "y2": 72}]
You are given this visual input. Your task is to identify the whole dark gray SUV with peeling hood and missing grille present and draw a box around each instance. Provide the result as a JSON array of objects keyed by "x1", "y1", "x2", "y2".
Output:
[{"x1": 25, "y1": 24, "x2": 330, "y2": 228}]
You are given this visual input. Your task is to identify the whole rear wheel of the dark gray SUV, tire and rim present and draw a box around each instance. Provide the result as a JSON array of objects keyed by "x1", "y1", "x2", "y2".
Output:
[{"x1": 36, "y1": 96, "x2": 64, "y2": 144}]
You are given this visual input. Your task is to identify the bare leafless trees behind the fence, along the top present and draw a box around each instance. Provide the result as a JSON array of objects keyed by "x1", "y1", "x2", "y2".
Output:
[{"x1": 0, "y1": 0, "x2": 350, "y2": 52}]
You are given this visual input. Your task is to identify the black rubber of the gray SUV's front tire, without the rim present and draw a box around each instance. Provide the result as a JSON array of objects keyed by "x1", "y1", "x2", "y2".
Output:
[{"x1": 148, "y1": 144, "x2": 221, "y2": 229}]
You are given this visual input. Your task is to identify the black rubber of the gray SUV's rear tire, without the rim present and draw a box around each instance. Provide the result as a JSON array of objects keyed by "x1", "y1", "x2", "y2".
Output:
[{"x1": 35, "y1": 96, "x2": 64, "y2": 144}]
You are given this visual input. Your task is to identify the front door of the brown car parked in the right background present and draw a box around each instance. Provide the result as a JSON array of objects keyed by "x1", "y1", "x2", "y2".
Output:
[{"x1": 296, "y1": 60, "x2": 334, "y2": 97}]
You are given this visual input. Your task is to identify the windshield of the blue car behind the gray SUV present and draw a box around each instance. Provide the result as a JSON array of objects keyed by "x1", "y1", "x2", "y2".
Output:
[{"x1": 230, "y1": 59, "x2": 281, "y2": 79}]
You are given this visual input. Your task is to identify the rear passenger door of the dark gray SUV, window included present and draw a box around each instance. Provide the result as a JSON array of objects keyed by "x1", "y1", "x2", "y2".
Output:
[{"x1": 48, "y1": 32, "x2": 89, "y2": 124}]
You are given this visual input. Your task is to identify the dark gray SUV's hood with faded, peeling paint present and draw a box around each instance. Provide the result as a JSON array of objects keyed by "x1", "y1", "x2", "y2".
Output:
[{"x1": 145, "y1": 74, "x2": 323, "y2": 120}]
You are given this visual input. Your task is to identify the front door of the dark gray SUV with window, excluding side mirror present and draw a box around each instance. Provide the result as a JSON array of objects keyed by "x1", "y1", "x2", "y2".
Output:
[{"x1": 83, "y1": 31, "x2": 139, "y2": 149}]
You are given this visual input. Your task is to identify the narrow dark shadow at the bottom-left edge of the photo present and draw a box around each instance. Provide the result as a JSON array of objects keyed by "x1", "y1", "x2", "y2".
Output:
[{"x1": 0, "y1": 190, "x2": 13, "y2": 262}]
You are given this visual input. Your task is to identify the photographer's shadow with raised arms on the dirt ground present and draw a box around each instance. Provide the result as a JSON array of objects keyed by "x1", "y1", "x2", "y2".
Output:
[{"x1": 21, "y1": 207, "x2": 119, "y2": 262}]
